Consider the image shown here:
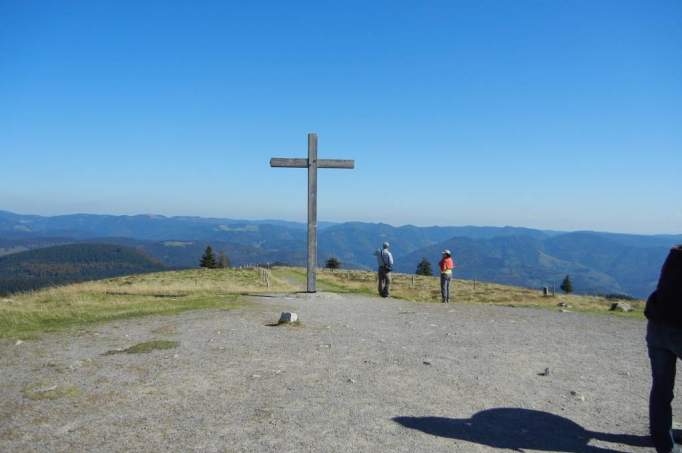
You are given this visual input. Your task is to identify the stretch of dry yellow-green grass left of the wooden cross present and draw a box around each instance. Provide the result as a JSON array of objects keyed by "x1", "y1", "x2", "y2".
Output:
[{"x1": 0, "y1": 269, "x2": 293, "y2": 338}]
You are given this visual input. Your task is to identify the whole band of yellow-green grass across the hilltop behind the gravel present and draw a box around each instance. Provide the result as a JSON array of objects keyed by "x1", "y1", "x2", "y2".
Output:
[{"x1": 0, "y1": 267, "x2": 643, "y2": 338}]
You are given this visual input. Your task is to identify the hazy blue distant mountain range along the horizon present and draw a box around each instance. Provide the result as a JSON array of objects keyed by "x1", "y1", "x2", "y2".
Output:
[{"x1": 0, "y1": 211, "x2": 682, "y2": 297}]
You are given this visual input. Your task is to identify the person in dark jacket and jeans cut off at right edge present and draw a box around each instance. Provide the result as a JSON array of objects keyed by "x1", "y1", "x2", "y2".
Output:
[{"x1": 644, "y1": 245, "x2": 682, "y2": 453}]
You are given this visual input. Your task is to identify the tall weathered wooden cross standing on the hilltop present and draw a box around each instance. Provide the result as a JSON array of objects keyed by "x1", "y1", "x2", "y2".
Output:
[{"x1": 270, "y1": 134, "x2": 355, "y2": 293}]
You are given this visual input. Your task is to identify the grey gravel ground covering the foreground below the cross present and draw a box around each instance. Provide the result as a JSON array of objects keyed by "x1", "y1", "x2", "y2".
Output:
[{"x1": 0, "y1": 293, "x2": 682, "y2": 452}]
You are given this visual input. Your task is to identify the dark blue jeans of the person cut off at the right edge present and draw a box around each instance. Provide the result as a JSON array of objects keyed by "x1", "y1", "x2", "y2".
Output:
[{"x1": 646, "y1": 321, "x2": 682, "y2": 453}]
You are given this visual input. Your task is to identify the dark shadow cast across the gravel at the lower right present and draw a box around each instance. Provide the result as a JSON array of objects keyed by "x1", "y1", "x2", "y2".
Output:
[{"x1": 393, "y1": 408, "x2": 651, "y2": 453}]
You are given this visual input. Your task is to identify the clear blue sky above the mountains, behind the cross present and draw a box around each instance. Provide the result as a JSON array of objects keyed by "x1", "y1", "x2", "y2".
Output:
[{"x1": 0, "y1": 0, "x2": 682, "y2": 233}]
